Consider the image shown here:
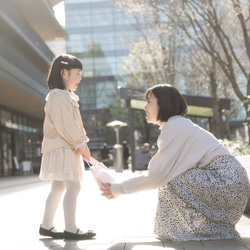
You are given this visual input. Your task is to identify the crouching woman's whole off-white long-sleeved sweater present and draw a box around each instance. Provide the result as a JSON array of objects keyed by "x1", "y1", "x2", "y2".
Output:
[{"x1": 111, "y1": 116, "x2": 230, "y2": 196}]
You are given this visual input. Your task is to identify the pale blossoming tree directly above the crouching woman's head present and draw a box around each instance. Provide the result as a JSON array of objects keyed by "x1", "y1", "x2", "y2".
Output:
[{"x1": 116, "y1": 0, "x2": 181, "y2": 88}]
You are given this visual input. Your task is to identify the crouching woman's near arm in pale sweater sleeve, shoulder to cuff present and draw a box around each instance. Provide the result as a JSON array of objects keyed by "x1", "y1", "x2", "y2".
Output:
[{"x1": 107, "y1": 119, "x2": 203, "y2": 196}]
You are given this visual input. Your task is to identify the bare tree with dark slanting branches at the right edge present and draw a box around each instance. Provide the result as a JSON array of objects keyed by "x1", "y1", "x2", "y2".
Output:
[{"x1": 158, "y1": 0, "x2": 250, "y2": 144}]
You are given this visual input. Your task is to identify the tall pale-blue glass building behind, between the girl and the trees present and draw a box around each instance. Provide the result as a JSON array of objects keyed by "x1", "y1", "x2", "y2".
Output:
[{"x1": 64, "y1": 0, "x2": 138, "y2": 146}]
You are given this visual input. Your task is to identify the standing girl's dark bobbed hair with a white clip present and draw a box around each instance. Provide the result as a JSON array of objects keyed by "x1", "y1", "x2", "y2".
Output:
[{"x1": 47, "y1": 54, "x2": 82, "y2": 90}]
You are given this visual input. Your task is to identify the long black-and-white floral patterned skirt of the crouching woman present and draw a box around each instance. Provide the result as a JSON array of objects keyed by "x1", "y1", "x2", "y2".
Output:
[{"x1": 154, "y1": 155, "x2": 250, "y2": 241}]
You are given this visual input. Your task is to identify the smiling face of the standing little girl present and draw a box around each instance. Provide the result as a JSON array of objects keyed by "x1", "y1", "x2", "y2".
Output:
[{"x1": 62, "y1": 69, "x2": 82, "y2": 91}]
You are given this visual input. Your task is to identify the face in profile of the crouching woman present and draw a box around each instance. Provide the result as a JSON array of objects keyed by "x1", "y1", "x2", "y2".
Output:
[{"x1": 144, "y1": 91, "x2": 161, "y2": 125}]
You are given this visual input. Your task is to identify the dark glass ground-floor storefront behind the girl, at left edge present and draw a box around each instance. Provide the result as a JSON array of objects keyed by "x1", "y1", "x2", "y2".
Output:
[{"x1": 0, "y1": 106, "x2": 42, "y2": 177}]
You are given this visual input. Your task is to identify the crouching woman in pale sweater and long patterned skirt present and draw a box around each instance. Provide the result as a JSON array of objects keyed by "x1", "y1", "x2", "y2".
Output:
[{"x1": 100, "y1": 84, "x2": 250, "y2": 241}]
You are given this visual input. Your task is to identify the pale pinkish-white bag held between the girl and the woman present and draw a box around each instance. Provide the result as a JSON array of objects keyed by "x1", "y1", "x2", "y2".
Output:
[{"x1": 88, "y1": 157, "x2": 115, "y2": 187}]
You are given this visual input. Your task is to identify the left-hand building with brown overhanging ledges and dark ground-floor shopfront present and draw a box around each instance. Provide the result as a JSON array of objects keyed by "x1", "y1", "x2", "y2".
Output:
[{"x1": 0, "y1": 0, "x2": 67, "y2": 177}]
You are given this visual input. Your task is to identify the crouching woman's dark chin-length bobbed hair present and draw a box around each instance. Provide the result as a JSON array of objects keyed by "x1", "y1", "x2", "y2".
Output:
[{"x1": 145, "y1": 84, "x2": 187, "y2": 122}]
